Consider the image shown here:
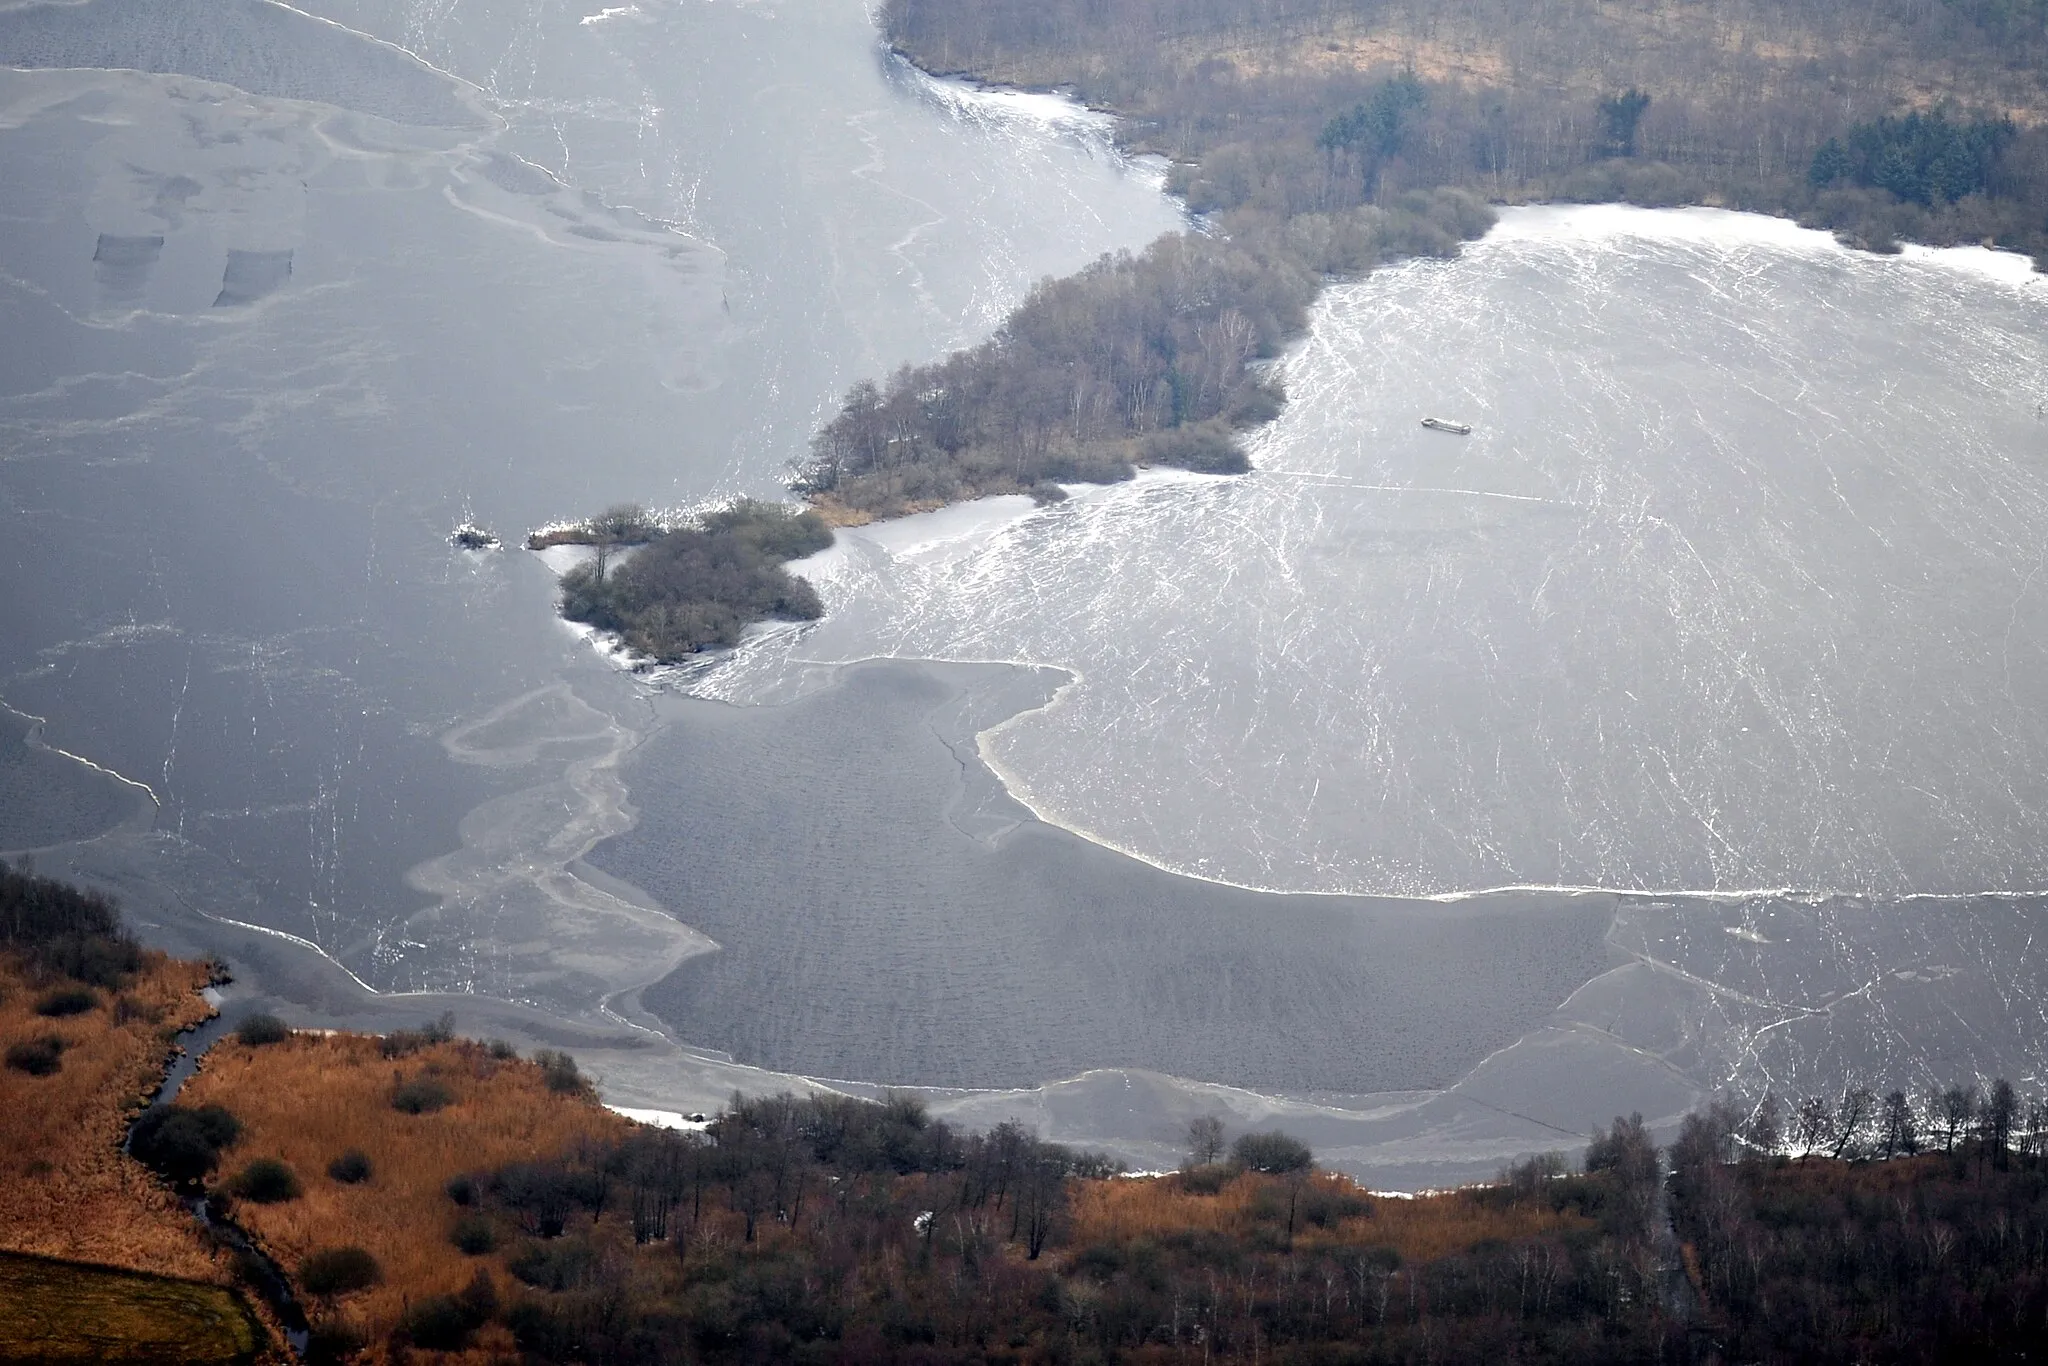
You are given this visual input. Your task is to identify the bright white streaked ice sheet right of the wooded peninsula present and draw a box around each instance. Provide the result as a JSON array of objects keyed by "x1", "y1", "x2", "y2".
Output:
[{"x1": 709, "y1": 209, "x2": 2048, "y2": 895}]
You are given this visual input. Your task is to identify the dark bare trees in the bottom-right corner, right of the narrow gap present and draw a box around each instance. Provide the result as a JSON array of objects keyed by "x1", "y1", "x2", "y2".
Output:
[{"x1": 1671, "y1": 1081, "x2": 2048, "y2": 1364}]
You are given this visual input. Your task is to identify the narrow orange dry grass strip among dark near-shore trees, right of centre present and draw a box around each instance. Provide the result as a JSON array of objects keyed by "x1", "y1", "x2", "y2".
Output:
[{"x1": 1073, "y1": 1171, "x2": 1591, "y2": 1262}]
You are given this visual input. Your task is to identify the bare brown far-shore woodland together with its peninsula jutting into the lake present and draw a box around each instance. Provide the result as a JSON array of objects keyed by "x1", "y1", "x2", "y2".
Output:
[{"x1": 795, "y1": 0, "x2": 2048, "y2": 522}]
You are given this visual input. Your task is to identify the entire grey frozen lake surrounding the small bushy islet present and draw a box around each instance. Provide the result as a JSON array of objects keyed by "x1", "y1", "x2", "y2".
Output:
[{"x1": 0, "y1": 0, "x2": 2048, "y2": 1184}]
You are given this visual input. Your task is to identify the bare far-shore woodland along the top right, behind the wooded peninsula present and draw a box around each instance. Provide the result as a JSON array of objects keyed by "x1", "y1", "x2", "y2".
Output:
[{"x1": 885, "y1": 0, "x2": 2048, "y2": 260}]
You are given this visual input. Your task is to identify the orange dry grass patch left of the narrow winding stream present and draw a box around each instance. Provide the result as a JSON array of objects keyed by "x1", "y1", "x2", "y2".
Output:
[{"x1": 0, "y1": 954, "x2": 229, "y2": 1282}]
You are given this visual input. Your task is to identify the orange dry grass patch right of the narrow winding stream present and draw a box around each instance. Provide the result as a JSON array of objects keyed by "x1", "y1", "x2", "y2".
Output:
[{"x1": 180, "y1": 1034, "x2": 631, "y2": 1360}]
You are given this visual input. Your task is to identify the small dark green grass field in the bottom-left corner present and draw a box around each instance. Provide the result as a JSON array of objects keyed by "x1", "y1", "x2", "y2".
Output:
[{"x1": 0, "y1": 1251, "x2": 264, "y2": 1366}]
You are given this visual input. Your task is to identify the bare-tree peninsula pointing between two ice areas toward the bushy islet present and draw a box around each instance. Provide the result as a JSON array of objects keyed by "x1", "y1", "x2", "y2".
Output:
[{"x1": 795, "y1": 190, "x2": 1493, "y2": 522}]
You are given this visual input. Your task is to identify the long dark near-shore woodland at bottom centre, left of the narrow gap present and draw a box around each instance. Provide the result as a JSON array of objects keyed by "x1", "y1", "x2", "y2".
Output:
[{"x1": 296, "y1": 1096, "x2": 1695, "y2": 1364}]
